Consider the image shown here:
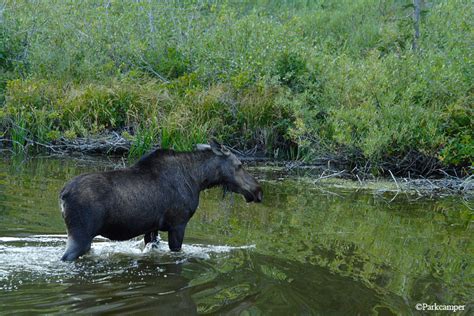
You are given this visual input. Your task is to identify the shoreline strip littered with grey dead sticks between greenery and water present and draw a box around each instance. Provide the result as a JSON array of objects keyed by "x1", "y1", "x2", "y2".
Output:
[{"x1": 0, "y1": 136, "x2": 474, "y2": 196}]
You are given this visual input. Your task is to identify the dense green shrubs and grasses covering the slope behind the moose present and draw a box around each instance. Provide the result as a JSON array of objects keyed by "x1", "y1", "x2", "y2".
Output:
[{"x1": 0, "y1": 0, "x2": 474, "y2": 173}]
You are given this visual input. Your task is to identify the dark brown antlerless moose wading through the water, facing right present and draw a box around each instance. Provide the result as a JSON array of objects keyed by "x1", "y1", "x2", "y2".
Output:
[{"x1": 59, "y1": 139, "x2": 263, "y2": 261}]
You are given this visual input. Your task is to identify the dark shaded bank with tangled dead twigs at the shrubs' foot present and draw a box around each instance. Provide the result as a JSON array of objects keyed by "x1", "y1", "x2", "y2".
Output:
[{"x1": 0, "y1": 131, "x2": 474, "y2": 180}]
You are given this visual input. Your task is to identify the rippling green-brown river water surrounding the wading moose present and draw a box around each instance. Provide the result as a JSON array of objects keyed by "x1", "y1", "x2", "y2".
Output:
[{"x1": 0, "y1": 157, "x2": 473, "y2": 315}]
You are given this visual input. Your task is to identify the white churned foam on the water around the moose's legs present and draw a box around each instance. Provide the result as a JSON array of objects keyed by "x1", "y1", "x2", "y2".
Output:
[{"x1": 0, "y1": 235, "x2": 255, "y2": 280}]
